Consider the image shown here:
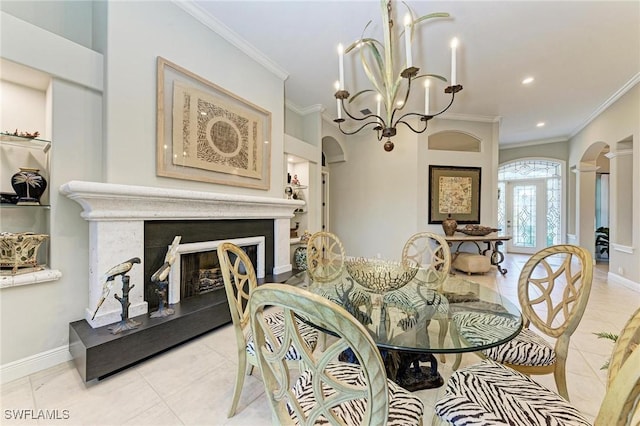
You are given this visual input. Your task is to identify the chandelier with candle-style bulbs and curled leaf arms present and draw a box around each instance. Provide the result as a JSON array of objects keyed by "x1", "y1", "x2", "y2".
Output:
[{"x1": 333, "y1": 0, "x2": 462, "y2": 151}]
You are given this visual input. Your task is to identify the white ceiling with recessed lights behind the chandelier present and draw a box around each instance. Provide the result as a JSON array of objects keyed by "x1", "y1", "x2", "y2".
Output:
[{"x1": 191, "y1": 0, "x2": 640, "y2": 148}]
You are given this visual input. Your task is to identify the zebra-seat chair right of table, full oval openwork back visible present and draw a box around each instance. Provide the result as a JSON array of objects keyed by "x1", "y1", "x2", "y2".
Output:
[{"x1": 452, "y1": 244, "x2": 593, "y2": 401}]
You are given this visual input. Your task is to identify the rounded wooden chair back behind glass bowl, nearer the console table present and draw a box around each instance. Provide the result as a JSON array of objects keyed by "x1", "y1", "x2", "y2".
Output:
[{"x1": 402, "y1": 232, "x2": 451, "y2": 290}]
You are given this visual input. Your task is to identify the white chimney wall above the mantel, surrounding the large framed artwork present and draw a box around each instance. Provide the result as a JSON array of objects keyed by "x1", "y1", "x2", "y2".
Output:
[{"x1": 105, "y1": 2, "x2": 284, "y2": 198}]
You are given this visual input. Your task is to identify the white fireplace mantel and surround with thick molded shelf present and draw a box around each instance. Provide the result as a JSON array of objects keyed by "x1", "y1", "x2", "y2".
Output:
[{"x1": 60, "y1": 181, "x2": 304, "y2": 328}]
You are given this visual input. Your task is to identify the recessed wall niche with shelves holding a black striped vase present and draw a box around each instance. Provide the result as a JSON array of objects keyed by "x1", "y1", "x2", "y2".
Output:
[{"x1": 0, "y1": 59, "x2": 61, "y2": 288}]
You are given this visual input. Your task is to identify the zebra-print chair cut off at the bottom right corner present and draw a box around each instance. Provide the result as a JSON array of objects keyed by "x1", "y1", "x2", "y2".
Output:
[{"x1": 432, "y1": 309, "x2": 640, "y2": 426}]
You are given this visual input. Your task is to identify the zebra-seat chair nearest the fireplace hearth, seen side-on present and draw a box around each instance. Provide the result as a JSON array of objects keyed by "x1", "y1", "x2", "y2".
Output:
[{"x1": 217, "y1": 242, "x2": 318, "y2": 417}]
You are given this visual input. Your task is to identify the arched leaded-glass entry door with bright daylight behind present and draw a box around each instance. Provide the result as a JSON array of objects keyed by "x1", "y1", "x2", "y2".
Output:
[{"x1": 498, "y1": 159, "x2": 563, "y2": 252}]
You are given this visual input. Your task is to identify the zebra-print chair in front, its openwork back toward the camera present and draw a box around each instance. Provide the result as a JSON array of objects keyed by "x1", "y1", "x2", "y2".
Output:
[{"x1": 249, "y1": 284, "x2": 424, "y2": 426}]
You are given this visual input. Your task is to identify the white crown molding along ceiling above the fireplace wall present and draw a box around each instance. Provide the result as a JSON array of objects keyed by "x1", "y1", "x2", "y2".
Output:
[{"x1": 172, "y1": 0, "x2": 289, "y2": 81}]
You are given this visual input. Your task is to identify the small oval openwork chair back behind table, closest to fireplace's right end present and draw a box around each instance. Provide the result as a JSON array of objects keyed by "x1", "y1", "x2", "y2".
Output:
[{"x1": 307, "y1": 231, "x2": 345, "y2": 282}]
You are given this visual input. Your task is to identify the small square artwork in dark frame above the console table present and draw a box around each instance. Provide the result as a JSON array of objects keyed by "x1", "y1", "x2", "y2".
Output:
[{"x1": 429, "y1": 165, "x2": 482, "y2": 224}]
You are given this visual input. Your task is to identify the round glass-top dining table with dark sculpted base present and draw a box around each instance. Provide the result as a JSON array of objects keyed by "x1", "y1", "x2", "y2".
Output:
[{"x1": 285, "y1": 269, "x2": 522, "y2": 391}]
